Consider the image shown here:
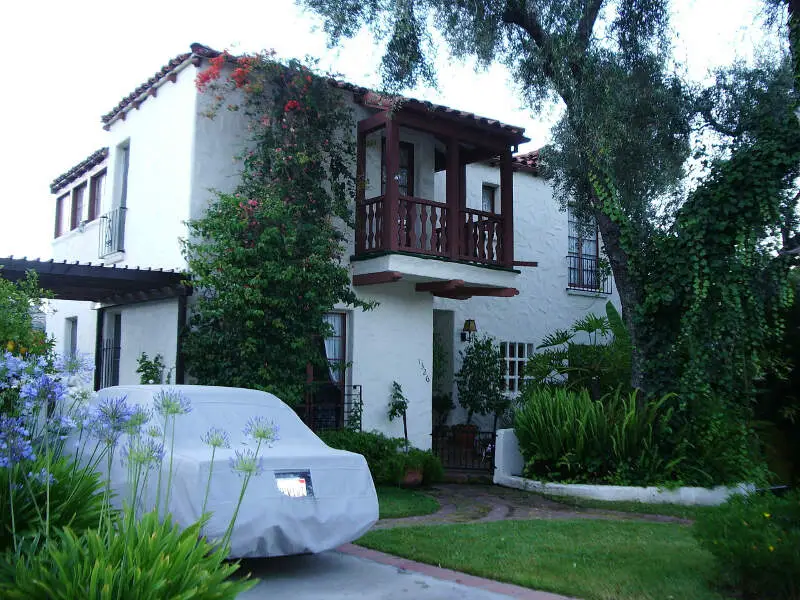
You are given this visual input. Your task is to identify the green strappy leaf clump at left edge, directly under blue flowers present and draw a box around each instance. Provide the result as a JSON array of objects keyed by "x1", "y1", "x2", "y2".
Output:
[{"x1": 0, "y1": 454, "x2": 104, "y2": 552}]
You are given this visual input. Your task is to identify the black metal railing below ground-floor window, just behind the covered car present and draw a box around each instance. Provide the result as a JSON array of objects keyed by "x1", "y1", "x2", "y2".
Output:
[{"x1": 295, "y1": 382, "x2": 362, "y2": 431}]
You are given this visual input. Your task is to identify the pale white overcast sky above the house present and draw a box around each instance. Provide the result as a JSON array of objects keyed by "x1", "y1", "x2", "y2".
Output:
[{"x1": 0, "y1": 0, "x2": 776, "y2": 257}]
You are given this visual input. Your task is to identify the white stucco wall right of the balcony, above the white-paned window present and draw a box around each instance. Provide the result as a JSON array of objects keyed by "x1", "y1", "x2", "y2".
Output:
[{"x1": 434, "y1": 164, "x2": 619, "y2": 428}]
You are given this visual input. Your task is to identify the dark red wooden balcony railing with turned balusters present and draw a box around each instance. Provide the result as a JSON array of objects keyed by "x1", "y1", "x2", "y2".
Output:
[{"x1": 356, "y1": 196, "x2": 504, "y2": 265}]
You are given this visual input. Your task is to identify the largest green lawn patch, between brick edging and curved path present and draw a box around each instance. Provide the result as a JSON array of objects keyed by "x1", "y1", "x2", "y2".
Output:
[{"x1": 357, "y1": 519, "x2": 722, "y2": 600}]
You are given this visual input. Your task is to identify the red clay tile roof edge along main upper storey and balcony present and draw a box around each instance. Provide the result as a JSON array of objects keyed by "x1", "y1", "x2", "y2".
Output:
[{"x1": 98, "y1": 43, "x2": 527, "y2": 143}]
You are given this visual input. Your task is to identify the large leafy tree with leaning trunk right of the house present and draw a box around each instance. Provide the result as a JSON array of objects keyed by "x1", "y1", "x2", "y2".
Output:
[{"x1": 299, "y1": 0, "x2": 798, "y2": 391}]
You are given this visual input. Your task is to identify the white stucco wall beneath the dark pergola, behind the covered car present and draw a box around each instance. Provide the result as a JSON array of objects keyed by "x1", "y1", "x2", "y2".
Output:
[{"x1": 114, "y1": 299, "x2": 178, "y2": 385}]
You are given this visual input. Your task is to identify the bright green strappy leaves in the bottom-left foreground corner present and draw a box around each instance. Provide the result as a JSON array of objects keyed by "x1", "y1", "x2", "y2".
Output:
[{"x1": 0, "y1": 512, "x2": 255, "y2": 600}]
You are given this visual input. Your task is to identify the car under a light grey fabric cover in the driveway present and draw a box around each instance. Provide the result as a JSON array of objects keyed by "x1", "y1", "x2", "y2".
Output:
[{"x1": 78, "y1": 385, "x2": 378, "y2": 557}]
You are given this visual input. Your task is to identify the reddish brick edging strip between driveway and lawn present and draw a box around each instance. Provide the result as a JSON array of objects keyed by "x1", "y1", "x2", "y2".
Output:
[{"x1": 336, "y1": 544, "x2": 577, "y2": 600}]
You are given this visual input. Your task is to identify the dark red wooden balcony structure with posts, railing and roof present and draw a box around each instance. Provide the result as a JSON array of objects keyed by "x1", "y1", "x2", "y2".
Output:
[{"x1": 356, "y1": 94, "x2": 527, "y2": 268}]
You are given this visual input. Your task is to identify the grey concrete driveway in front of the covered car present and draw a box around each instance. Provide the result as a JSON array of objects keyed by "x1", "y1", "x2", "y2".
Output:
[{"x1": 237, "y1": 544, "x2": 566, "y2": 600}]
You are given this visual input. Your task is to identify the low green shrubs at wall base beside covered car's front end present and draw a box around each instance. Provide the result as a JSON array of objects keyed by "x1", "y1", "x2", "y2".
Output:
[{"x1": 319, "y1": 430, "x2": 444, "y2": 485}]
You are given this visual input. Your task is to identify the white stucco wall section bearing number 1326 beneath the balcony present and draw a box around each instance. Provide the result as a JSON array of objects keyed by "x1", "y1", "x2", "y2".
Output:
[{"x1": 351, "y1": 282, "x2": 433, "y2": 449}]
